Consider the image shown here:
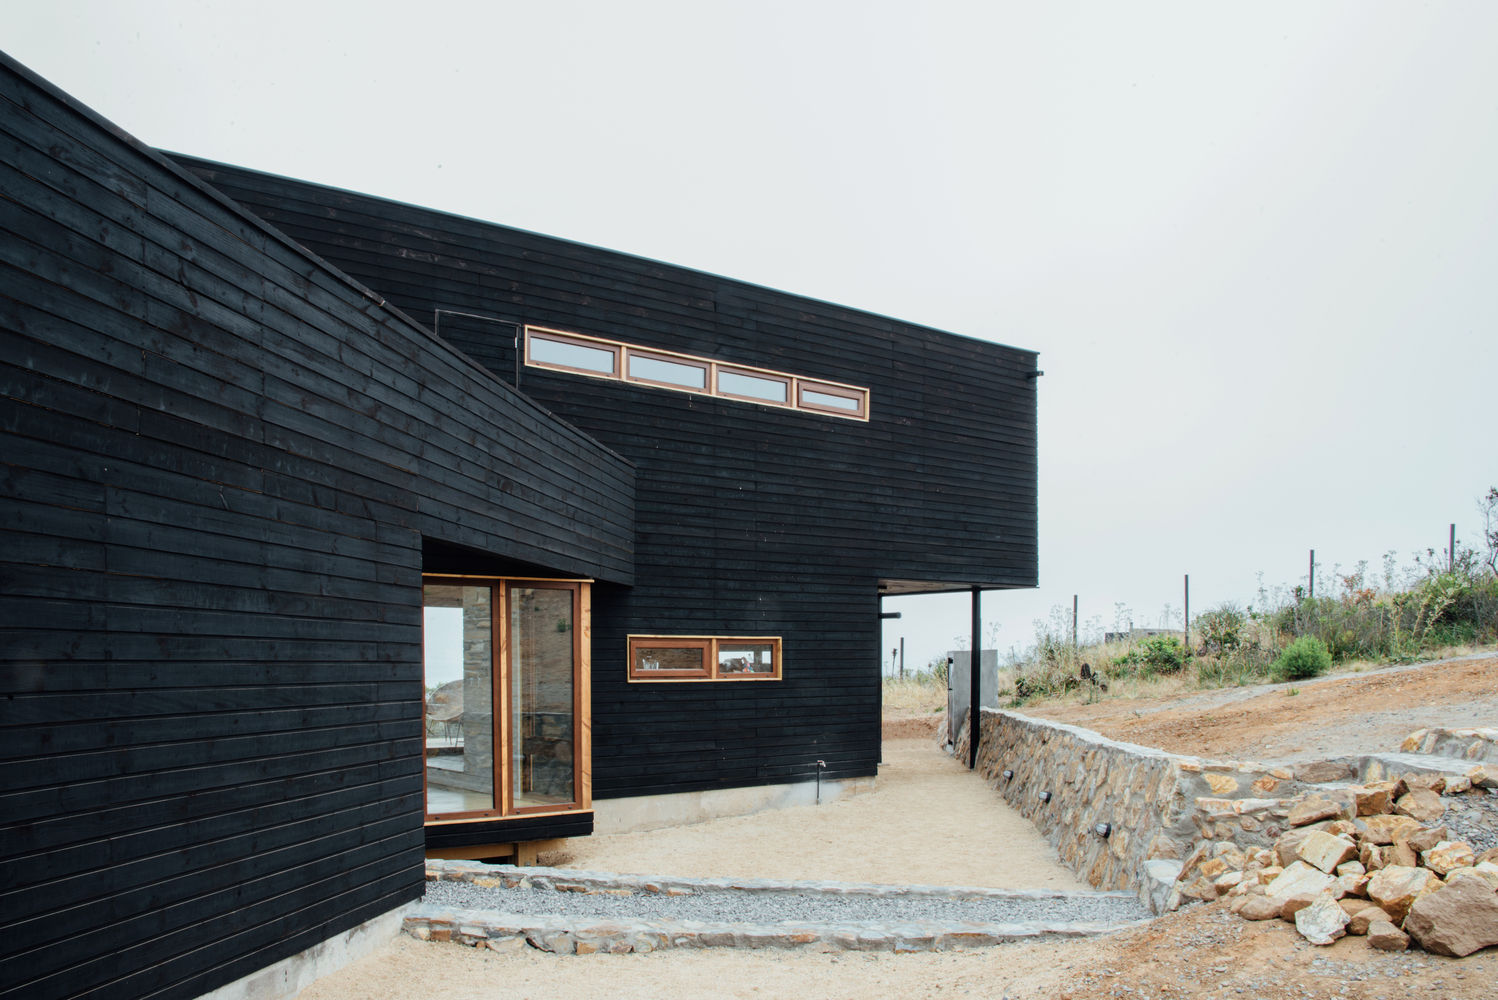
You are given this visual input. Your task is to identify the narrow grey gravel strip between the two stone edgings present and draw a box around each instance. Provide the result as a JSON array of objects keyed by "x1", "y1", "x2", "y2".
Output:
[{"x1": 422, "y1": 882, "x2": 1149, "y2": 924}]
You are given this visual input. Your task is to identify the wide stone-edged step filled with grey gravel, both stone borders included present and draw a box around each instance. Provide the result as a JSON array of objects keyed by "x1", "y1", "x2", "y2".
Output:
[{"x1": 404, "y1": 861, "x2": 1147, "y2": 954}]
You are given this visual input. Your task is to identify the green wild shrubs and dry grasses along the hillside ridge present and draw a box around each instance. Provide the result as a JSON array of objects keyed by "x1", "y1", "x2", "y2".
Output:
[{"x1": 1001, "y1": 488, "x2": 1498, "y2": 705}]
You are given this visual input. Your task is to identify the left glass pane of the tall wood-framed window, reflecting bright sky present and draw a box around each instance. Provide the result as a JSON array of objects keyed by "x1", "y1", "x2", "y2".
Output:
[{"x1": 422, "y1": 585, "x2": 494, "y2": 813}]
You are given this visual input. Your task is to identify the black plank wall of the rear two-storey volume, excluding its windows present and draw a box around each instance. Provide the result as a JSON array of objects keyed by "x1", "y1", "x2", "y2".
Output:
[{"x1": 178, "y1": 157, "x2": 1037, "y2": 799}]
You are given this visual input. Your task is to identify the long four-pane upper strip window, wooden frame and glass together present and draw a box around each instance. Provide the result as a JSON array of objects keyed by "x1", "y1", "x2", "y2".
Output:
[{"x1": 526, "y1": 326, "x2": 869, "y2": 421}]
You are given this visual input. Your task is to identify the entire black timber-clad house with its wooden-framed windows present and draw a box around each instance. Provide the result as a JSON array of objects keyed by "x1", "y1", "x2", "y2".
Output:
[{"x1": 0, "y1": 61, "x2": 1037, "y2": 997}]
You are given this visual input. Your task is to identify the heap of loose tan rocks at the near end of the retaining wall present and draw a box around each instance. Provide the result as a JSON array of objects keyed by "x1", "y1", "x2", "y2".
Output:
[{"x1": 1177, "y1": 769, "x2": 1498, "y2": 958}]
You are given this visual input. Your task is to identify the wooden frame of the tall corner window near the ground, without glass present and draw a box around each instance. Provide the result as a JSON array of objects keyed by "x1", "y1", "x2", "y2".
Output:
[{"x1": 421, "y1": 573, "x2": 593, "y2": 826}]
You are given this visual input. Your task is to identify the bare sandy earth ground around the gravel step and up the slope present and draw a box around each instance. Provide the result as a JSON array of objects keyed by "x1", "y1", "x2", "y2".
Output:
[{"x1": 301, "y1": 656, "x2": 1498, "y2": 1000}]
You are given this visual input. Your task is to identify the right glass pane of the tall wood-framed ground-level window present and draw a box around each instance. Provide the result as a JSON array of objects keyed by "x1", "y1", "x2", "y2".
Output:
[{"x1": 509, "y1": 587, "x2": 577, "y2": 808}]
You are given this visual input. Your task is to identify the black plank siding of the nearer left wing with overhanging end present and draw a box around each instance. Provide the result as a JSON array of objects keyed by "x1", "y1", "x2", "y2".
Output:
[{"x1": 0, "y1": 60, "x2": 634, "y2": 999}]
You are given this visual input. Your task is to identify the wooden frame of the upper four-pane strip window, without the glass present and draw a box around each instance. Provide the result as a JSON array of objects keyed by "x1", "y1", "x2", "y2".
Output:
[{"x1": 524, "y1": 325, "x2": 870, "y2": 422}]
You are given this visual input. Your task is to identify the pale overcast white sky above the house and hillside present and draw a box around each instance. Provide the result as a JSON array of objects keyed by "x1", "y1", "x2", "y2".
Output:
[{"x1": 0, "y1": 0, "x2": 1498, "y2": 665}]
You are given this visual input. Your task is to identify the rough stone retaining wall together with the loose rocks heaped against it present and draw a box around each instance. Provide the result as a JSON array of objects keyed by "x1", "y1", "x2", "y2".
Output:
[{"x1": 956, "y1": 710, "x2": 1498, "y2": 955}]
